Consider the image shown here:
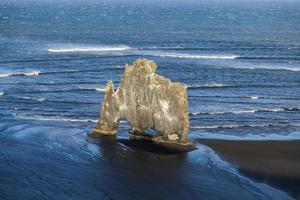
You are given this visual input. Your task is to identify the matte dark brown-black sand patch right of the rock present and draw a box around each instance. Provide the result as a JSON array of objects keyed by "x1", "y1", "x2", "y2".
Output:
[{"x1": 198, "y1": 139, "x2": 300, "y2": 199}]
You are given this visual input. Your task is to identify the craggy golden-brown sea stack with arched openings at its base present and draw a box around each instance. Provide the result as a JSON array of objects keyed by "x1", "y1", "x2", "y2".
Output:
[{"x1": 93, "y1": 59, "x2": 189, "y2": 144}]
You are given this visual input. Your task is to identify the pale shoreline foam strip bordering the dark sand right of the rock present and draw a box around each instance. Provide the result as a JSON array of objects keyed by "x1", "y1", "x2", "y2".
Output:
[{"x1": 191, "y1": 132, "x2": 300, "y2": 141}]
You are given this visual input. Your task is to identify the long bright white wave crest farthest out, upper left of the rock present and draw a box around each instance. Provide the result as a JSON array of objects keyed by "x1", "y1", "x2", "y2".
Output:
[{"x1": 47, "y1": 45, "x2": 131, "y2": 53}]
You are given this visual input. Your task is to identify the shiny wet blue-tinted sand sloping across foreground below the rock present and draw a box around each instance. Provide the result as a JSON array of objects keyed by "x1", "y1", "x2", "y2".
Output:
[{"x1": 0, "y1": 122, "x2": 292, "y2": 200}]
